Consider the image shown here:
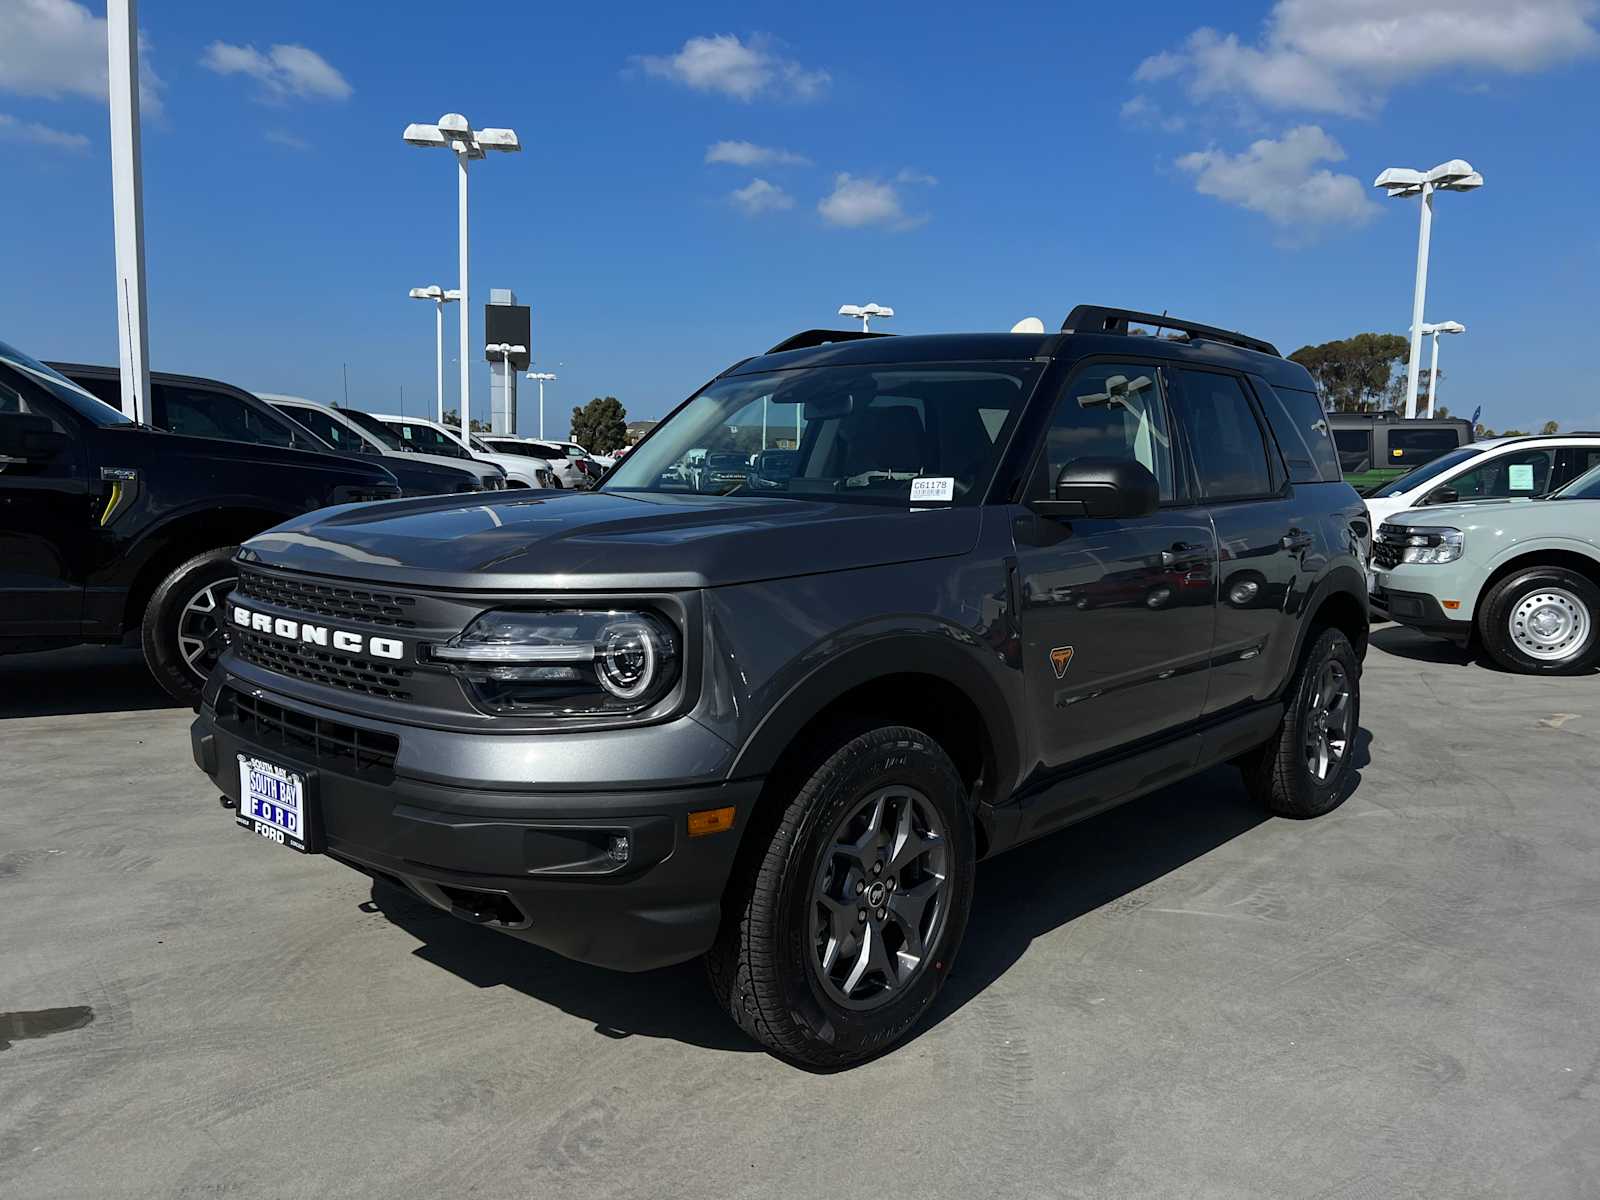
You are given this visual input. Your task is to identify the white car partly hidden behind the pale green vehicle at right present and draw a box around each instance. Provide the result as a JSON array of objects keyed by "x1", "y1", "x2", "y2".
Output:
[{"x1": 1365, "y1": 434, "x2": 1600, "y2": 530}]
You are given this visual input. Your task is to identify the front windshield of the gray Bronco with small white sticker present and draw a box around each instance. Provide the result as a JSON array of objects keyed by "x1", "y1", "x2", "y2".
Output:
[{"x1": 602, "y1": 363, "x2": 1038, "y2": 504}]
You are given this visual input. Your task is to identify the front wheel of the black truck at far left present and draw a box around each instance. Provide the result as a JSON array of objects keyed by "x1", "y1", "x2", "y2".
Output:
[{"x1": 139, "y1": 546, "x2": 238, "y2": 707}]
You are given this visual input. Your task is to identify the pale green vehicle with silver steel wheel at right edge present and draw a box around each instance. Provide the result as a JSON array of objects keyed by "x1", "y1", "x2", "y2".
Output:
[{"x1": 1371, "y1": 466, "x2": 1600, "y2": 675}]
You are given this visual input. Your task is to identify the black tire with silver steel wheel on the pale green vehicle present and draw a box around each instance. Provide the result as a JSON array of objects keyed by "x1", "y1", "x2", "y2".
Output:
[{"x1": 1475, "y1": 566, "x2": 1600, "y2": 675}]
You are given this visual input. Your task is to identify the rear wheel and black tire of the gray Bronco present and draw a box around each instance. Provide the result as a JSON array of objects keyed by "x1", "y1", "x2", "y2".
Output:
[{"x1": 1240, "y1": 629, "x2": 1362, "y2": 818}]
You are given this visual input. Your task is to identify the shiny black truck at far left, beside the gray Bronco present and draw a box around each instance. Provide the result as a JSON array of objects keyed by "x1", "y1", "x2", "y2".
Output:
[{"x1": 0, "y1": 344, "x2": 400, "y2": 704}]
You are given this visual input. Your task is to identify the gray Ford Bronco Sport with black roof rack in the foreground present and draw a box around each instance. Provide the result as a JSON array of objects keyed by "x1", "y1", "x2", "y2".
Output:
[{"x1": 192, "y1": 307, "x2": 1368, "y2": 1069}]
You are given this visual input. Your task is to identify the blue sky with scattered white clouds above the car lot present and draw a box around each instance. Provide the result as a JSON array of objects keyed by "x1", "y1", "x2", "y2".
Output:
[{"x1": 0, "y1": 0, "x2": 1600, "y2": 434}]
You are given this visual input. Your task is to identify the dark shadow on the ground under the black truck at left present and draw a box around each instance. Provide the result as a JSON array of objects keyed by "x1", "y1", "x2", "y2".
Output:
[{"x1": 0, "y1": 646, "x2": 178, "y2": 718}]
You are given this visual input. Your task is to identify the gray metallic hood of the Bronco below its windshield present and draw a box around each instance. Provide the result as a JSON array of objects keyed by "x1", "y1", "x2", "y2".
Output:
[{"x1": 245, "y1": 491, "x2": 981, "y2": 592}]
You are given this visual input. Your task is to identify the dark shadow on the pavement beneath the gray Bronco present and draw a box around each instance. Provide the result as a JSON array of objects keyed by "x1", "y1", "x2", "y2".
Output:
[{"x1": 362, "y1": 730, "x2": 1371, "y2": 1053}]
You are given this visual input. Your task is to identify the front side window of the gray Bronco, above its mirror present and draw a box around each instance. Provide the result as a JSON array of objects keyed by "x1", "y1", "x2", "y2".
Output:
[{"x1": 1036, "y1": 363, "x2": 1178, "y2": 501}]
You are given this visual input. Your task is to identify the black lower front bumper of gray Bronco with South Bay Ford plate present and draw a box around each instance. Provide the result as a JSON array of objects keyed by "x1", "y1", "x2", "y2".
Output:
[{"x1": 190, "y1": 686, "x2": 762, "y2": 971}]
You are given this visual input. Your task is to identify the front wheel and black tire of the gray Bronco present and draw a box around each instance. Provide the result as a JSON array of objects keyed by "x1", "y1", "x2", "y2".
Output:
[{"x1": 706, "y1": 726, "x2": 974, "y2": 1070}]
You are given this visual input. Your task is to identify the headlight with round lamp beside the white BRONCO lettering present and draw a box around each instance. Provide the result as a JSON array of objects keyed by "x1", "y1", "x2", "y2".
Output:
[{"x1": 430, "y1": 610, "x2": 682, "y2": 717}]
